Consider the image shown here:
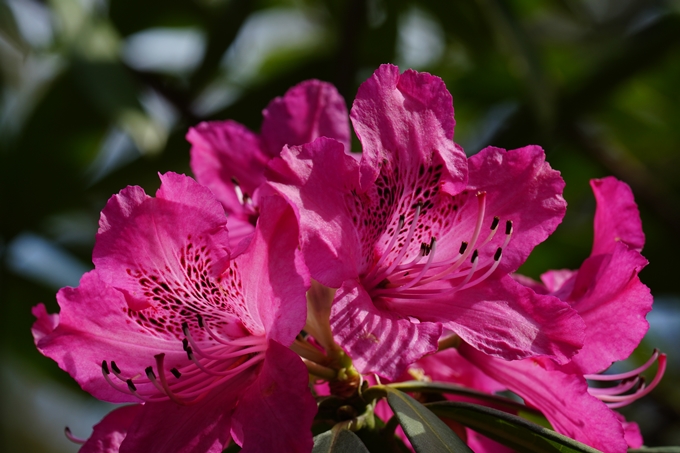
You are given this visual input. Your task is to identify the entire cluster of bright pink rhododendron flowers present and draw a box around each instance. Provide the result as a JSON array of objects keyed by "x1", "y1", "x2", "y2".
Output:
[{"x1": 33, "y1": 65, "x2": 665, "y2": 452}]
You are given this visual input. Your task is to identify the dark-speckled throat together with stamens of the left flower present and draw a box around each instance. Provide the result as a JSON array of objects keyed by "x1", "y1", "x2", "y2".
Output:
[{"x1": 102, "y1": 236, "x2": 267, "y2": 405}]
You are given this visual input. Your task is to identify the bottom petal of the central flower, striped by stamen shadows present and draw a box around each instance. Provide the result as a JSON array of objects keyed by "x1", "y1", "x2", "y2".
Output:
[{"x1": 331, "y1": 281, "x2": 441, "y2": 380}]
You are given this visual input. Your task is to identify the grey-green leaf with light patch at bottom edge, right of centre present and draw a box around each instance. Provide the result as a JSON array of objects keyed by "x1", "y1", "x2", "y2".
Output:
[{"x1": 385, "y1": 387, "x2": 472, "y2": 453}]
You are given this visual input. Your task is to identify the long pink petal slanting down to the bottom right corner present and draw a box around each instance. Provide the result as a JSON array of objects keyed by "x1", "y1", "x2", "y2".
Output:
[{"x1": 459, "y1": 345, "x2": 627, "y2": 453}]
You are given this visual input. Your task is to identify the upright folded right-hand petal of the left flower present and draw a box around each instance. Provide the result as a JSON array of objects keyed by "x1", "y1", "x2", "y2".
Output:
[{"x1": 235, "y1": 192, "x2": 310, "y2": 345}]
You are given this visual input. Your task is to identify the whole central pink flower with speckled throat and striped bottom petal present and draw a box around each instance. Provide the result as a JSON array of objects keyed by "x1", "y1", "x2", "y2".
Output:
[{"x1": 269, "y1": 65, "x2": 583, "y2": 378}]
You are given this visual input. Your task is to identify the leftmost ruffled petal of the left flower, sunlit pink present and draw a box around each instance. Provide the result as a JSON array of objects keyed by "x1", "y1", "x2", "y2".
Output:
[{"x1": 36, "y1": 271, "x2": 186, "y2": 402}]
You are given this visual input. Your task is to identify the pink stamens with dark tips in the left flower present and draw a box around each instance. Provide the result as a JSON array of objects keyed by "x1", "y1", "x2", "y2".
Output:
[{"x1": 102, "y1": 315, "x2": 267, "y2": 405}]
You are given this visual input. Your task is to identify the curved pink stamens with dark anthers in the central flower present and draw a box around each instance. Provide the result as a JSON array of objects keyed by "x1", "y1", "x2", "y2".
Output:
[{"x1": 362, "y1": 192, "x2": 513, "y2": 299}]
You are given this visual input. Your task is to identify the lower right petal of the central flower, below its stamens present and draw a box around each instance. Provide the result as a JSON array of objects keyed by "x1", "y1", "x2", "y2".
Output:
[{"x1": 389, "y1": 276, "x2": 585, "y2": 363}]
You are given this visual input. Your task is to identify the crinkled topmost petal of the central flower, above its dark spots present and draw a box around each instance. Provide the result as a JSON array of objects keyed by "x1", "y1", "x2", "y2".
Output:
[{"x1": 350, "y1": 65, "x2": 467, "y2": 193}]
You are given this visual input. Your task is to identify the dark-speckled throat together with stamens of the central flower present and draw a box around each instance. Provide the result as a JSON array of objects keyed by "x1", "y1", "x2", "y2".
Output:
[{"x1": 348, "y1": 153, "x2": 512, "y2": 299}]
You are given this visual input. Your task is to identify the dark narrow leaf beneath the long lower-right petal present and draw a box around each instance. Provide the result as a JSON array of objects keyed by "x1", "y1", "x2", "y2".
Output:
[{"x1": 427, "y1": 401, "x2": 599, "y2": 453}]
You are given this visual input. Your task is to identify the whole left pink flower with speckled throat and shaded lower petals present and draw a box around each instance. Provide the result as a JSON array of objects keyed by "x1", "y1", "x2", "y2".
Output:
[{"x1": 34, "y1": 173, "x2": 316, "y2": 452}]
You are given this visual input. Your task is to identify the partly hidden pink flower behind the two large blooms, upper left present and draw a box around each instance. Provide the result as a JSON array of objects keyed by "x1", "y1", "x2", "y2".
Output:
[{"x1": 187, "y1": 80, "x2": 350, "y2": 248}]
